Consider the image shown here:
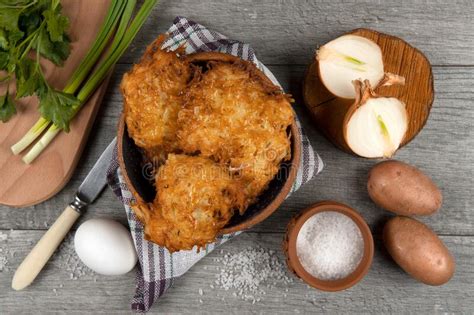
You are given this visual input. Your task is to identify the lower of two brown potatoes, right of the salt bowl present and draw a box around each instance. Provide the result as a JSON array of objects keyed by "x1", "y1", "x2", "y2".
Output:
[{"x1": 383, "y1": 216, "x2": 455, "y2": 285}]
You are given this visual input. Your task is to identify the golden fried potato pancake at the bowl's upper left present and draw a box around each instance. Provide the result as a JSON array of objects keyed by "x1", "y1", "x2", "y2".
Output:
[{"x1": 121, "y1": 36, "x2": 192, "y2": 156}]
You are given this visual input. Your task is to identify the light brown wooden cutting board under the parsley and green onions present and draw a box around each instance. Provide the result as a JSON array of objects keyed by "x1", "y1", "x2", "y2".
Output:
[{"x1": 0, "y1": 0, "x2": 110, "y2": 207}]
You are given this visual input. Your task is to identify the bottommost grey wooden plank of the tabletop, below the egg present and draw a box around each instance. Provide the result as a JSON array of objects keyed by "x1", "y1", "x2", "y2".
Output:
[{"x1": 0, "y1": 231, "x2": 474, "y2": 314}]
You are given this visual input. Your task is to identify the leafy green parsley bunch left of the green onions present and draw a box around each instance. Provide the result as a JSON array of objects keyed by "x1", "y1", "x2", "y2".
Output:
[{"x1": 0, "y1": 0, "x2": 80, "y2": 131}]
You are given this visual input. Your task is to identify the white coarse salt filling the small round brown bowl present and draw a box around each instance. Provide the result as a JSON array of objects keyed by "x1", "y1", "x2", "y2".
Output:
[{"x1": 296, "y1": 211, "x2": 364, "y2": 280}]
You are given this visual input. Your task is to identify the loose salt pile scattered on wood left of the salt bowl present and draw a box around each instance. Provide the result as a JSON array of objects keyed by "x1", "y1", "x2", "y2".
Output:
[{"x1": 215, "y1": 247, "x2": 293, "y2": 304}]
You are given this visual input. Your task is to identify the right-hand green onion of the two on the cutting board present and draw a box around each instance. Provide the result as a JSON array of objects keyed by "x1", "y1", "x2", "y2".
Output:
[{"x1": 23, "y1": 0, "x2": 158, "y2": 164}]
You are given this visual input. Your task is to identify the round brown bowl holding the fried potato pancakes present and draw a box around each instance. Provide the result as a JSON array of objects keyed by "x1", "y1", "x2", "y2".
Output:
[{"x1": 117, "y1": 52, "x2": 301, "y2": 234}]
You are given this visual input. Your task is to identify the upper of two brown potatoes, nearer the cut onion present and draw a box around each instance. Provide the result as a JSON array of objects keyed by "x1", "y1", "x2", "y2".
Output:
[{"x1": 367, "y1": 160, "x2": 443, "y2": 216}]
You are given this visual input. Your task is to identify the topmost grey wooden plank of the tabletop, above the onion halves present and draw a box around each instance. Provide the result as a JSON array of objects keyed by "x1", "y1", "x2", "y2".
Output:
[{"x1": 117, "y1": 0, "x2": 474, "y2": 65}]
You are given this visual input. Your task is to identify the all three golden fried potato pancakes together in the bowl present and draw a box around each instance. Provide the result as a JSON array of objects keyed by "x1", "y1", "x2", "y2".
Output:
[{"x1": 121, "y1": 37, "x2": 294, "y2": 252}]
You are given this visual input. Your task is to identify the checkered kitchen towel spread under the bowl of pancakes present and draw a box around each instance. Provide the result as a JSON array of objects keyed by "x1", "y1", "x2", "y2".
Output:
[{"x1": 108, "y1": 17, "x2": 323, "y2": 312}]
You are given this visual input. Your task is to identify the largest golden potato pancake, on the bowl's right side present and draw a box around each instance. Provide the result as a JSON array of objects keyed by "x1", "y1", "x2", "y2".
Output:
[{"x1": 178, "y1": 60, "x2": 294, "y2": 204}]
